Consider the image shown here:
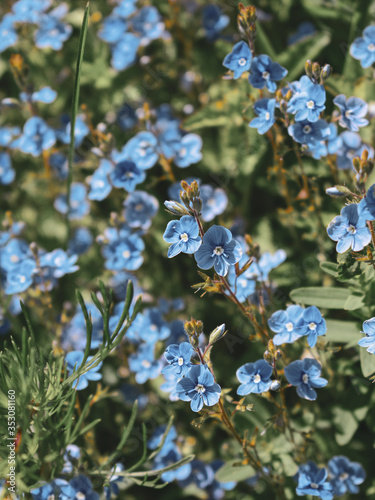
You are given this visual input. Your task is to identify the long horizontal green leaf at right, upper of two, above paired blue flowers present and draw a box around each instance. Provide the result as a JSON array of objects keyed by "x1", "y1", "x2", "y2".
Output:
[{"x1": 290, "y1": 286, "x2": 351, "y2": 309}]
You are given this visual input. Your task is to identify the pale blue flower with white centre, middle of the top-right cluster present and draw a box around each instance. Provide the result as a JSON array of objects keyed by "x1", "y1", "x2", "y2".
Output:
[{"x1": 288, "y1": 84, "x2": 326, "y2": 122}]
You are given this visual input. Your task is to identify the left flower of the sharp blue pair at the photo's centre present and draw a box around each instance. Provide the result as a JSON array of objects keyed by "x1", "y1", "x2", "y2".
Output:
[{"x1": 163, "y1": 215, "x2": 202, "y2": 258}]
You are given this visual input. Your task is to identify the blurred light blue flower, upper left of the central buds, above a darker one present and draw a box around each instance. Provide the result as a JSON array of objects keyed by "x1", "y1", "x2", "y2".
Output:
[{"x1": 122, "y1": 131, "x2": 159, "y2": 170}]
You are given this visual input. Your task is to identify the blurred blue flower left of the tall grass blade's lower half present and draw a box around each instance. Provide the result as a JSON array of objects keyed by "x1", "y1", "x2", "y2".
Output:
[{"x1": 11, "y1": 116, "x2": 56, "y2": 156}]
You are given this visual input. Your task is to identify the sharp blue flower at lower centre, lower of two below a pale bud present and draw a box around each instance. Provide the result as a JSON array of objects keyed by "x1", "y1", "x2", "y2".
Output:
[{"x1": 177, "y1": 365, "x2": 221, "y2": 412}]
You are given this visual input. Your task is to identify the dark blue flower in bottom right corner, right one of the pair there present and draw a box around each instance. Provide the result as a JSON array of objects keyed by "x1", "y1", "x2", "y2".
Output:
[{"x1": 328, "y1": 455, "x2": 366, "y2": 496}]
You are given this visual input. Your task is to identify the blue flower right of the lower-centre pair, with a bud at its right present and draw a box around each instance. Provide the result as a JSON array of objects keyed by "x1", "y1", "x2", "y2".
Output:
[{"x1": 236, "y1": 359, "x2": 272, "y2": 396}]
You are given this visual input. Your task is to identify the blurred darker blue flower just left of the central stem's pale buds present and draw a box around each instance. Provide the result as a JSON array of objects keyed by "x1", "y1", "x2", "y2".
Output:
[{"x1": 123, "y1": 191, "x2": 159, "y2": 229}]
